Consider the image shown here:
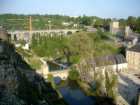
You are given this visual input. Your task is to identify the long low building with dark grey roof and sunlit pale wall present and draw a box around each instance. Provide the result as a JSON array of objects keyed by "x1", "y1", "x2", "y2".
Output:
[{"x1": 95, "y1": 54, "x2": 127, "y2": 72}]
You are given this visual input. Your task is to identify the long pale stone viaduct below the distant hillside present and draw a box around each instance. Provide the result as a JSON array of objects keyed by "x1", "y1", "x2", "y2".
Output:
[{"x1": 8, "y1": 29, "x2": 78, "y2": 41}]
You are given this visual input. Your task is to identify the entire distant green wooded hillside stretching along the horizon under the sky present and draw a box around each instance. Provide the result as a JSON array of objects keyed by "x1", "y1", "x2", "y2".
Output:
[{"x1": 0, "y1": 14, "x2": 140, "y2": 33}]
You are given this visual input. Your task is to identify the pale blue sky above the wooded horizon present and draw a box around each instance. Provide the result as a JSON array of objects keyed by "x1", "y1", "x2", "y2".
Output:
[{"x1": 0, "y1": 0, "x2": 140, "y2": 18}]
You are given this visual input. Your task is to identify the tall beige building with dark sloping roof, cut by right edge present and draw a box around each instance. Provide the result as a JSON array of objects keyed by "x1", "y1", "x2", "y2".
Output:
[{"x1": 126, "y1": 44, "x2": 140, "y2": 70}]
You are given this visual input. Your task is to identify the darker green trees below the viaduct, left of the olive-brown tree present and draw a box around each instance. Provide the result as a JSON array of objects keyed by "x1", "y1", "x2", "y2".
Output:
[{"x1": 31, "y1": 35, "x2": 67, "y2": 58}]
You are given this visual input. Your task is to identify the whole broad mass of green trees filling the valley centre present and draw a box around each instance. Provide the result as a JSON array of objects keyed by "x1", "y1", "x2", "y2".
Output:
[{"x1": 31, "y1": 31, "x2": 118, "y2": 64}]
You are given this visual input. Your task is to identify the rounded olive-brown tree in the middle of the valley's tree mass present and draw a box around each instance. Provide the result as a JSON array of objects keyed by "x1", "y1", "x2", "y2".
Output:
[{"x1": 70, "y1": 32, "x2": 93, "y2": 61}]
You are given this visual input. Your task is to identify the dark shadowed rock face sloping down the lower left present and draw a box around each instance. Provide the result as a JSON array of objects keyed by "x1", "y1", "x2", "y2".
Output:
[{"x1": 0, "y1": 41, "x2": 64, "y2": 105}]
